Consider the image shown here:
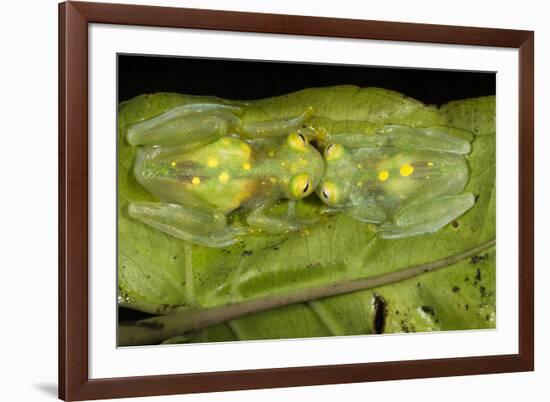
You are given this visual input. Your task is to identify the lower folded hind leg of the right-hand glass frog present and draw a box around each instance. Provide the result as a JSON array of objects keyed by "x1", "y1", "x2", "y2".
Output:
[{"x1": 379, "y1": 193, "x2": 474, "y2": 239}]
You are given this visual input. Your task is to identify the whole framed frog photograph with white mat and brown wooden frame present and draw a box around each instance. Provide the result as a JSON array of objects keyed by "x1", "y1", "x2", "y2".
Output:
[{"x1": 59, "y1": 2, "x2": 534, "y2": 400}]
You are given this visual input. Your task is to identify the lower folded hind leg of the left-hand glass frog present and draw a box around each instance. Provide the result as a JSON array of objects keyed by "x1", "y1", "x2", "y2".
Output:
[{"x1": 128, "y1": 201, "x2": 246, "y2": 247}]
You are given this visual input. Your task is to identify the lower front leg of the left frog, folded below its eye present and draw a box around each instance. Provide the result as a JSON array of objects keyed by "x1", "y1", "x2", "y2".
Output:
[{"x1": 246, "y1": 200, "x2": 316, "y2": 233}]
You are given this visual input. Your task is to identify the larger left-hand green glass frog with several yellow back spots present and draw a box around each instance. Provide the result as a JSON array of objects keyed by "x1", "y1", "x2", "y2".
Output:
[{"x1": 127, "y1": 104, "x2": 323, "y2": 247}]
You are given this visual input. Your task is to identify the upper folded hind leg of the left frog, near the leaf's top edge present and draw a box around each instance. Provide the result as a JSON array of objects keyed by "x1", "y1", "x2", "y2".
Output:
[{"x1": 126, "y1": 103, "x2": 242, "y2": 145}]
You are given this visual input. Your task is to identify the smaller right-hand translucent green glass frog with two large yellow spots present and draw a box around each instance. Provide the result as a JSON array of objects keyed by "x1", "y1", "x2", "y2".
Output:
[{"x1": 316, "y1": 125, "x2": 474, "y2": 238}]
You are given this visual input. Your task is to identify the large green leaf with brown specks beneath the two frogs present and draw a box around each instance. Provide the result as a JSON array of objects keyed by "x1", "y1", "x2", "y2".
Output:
[{"x1": 118, "y1": 86, "x2": 495, "y2": 342}]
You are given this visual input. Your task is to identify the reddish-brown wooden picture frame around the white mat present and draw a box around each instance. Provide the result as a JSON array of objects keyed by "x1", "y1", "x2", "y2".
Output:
[{"x1": 59, "y1": 2, "x2": 534, "y2": 400}]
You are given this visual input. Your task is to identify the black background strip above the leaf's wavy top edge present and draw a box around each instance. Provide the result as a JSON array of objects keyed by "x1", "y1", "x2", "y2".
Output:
[{"x1": 118, "y1": 55, "x2": 496, "y2": 106}]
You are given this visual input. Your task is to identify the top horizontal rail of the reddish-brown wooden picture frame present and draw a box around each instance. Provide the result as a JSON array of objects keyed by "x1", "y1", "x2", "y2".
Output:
[{"x1": 73, "y1": 2, "x2": 529, "y2": 47}]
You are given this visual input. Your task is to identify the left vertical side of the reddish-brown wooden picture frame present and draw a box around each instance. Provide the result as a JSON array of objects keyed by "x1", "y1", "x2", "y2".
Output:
[{"x1": 59, "y1": 3, "x2": 88, "y2": 400}]
